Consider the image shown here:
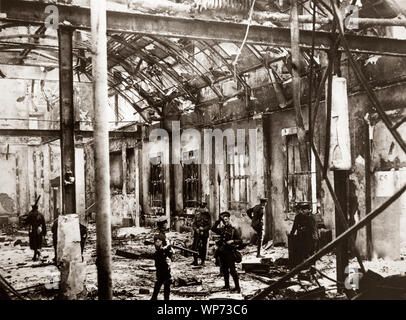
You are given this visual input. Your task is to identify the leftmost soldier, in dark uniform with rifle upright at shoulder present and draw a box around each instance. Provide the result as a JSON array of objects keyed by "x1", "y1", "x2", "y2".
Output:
[{"x1": 25, "y1": 201, "x2": 47, "y2": 261}]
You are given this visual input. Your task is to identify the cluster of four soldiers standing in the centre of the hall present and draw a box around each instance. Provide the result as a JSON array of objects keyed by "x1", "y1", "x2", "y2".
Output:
[{"x1": 152, "y1": 198, "x2": 267, "y2": 300}]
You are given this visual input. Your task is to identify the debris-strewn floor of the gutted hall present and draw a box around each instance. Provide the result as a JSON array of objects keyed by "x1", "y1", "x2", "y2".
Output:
[{"x1": 0, "y1": 225, "x2": 406, "y2": 300}]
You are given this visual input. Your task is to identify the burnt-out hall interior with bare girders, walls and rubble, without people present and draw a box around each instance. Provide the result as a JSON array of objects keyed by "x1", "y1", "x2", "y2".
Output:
[{"x1": 0, "y1": 0, "x2": 406, "y2": 300}]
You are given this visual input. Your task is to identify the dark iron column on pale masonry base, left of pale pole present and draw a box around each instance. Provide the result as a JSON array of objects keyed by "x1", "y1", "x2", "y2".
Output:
[{"x1": 58, "y1": 27, "x2": 76, "y2": 214}]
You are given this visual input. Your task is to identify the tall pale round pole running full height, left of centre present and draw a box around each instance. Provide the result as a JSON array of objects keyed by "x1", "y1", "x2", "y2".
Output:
[{"x1": 90, "y1": 0, "x2": 113, "y2": 300}]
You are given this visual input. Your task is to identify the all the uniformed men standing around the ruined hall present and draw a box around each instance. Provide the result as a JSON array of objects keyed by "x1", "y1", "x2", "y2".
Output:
[{"x1": 25, "y1": 198, "x2": 318, "y2": 300}]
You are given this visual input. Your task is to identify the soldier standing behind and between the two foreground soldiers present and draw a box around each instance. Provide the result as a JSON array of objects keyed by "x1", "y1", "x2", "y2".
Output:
[{"x1": 192, "y1": 202, "x2": 211, "y2": 266}]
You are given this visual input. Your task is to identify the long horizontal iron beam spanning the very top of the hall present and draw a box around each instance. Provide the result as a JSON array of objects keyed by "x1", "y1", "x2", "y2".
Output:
[{"x1": 0, "y1": 0, "x2": 406, "y2": 56}]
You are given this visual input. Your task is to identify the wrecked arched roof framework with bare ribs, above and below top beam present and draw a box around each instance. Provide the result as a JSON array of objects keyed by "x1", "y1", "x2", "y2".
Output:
[{"x1": 0, "y1": 0, "x2": 403, "y2": 123}]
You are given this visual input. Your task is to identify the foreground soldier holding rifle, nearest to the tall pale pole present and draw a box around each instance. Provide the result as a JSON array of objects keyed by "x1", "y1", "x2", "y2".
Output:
[{"x1": 151, "y1": 233, "x2": 172, "y2": 300}]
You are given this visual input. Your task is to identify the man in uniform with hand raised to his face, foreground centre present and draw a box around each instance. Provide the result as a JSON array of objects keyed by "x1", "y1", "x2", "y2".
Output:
[{"x1": 211, "y1": 212, "x2": 242, "y2": 292}]
